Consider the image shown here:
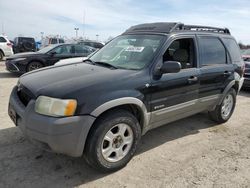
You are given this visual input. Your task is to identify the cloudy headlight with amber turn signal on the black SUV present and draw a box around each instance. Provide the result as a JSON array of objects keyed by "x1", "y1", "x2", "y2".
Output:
[{"x1": 35, "y1": 96, "x2": 77, "y2": 117}]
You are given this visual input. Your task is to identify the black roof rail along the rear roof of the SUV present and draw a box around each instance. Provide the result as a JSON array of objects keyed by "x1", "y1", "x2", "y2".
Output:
[{"x1": 182, "y1": 25, "x2": 230, "y2": 35}]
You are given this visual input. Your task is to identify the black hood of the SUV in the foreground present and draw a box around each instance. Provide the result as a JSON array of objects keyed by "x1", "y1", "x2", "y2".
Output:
[{"x1": 19, "y1": 63, "x2": 141, "y2": 98}]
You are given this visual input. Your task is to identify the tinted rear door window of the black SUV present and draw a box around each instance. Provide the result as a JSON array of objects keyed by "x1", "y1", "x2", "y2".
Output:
[{"x1": 199, "y1": 37, "x2": 227, "y2": 66}]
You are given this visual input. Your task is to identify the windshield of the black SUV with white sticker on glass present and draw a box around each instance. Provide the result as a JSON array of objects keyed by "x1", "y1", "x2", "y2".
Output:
[{"x1": 90, "y1": 35, "x2": 164, "y2": 70}]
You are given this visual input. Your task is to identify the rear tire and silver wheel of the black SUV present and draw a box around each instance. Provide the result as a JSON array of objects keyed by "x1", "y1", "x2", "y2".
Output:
[{"x1": 209, "y1": 88, "x2": 236, "y2": 123}]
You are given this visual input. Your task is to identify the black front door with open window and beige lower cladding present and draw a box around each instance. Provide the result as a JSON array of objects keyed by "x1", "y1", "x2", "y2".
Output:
[{"x1": 150, "y1": 36, "x2": 200, "y2": 128}]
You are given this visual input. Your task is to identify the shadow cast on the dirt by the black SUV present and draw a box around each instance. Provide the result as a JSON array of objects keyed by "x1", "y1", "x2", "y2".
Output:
[{"x1": 0, "y1": 114, "x2": 216, "y2": 187}]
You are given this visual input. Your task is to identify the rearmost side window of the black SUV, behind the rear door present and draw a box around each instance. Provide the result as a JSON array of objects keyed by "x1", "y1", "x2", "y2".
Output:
[{"x1": 222, "y1": 38, "x2": 241, "y2": 62}]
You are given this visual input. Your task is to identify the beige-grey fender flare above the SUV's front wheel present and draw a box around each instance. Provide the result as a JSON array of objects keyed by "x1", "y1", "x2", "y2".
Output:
[{"x1": 90, "y1": 97, "x2": 150, "y2": 132}]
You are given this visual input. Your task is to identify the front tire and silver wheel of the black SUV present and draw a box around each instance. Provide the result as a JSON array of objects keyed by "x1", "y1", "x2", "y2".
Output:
[{"x1": 84, "y1": 110, "x2": 141, "y2": 172}]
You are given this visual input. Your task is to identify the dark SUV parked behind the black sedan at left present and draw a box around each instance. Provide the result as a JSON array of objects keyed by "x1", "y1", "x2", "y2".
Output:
[{"x1": 13, "y1": 37, "x2": 36, "y2": 54}]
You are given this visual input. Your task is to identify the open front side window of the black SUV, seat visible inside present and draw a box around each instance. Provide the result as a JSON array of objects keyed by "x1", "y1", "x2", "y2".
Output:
[{"x1": 163, "y1": 38, "x2": 196, "y2": 69}]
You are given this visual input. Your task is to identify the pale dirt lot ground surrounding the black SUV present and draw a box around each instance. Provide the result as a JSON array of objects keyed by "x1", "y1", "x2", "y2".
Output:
[{"x1": 0, "y1": 62, "x2": 250, "y2": 188}]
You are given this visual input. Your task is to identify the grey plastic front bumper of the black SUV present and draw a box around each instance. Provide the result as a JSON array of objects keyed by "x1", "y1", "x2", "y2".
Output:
[{"x1": 9, "y1": 87, "x2": 95, "y2": 157}]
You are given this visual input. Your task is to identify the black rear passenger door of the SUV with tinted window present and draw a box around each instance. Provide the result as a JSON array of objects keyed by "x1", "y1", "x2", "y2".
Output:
[{"x1": 198, "y1": 36, "x2": 234, "y2": 100}]
